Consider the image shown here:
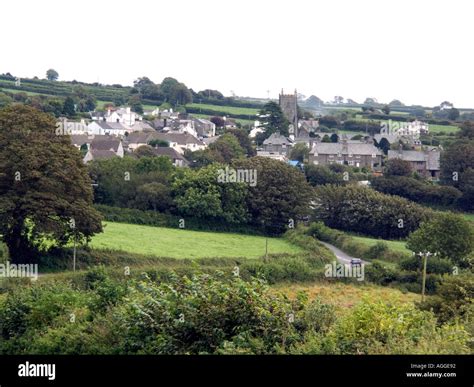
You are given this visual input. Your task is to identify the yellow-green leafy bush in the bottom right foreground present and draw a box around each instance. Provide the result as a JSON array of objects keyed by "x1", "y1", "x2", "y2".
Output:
[{"x1": 325, "y1": 300, "x2": 469, "y2": 354}]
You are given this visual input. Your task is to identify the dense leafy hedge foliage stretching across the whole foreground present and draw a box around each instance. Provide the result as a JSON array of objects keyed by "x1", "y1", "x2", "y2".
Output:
[{"x1": 0, "y1": 269, "x2": 470, "y2": 354}]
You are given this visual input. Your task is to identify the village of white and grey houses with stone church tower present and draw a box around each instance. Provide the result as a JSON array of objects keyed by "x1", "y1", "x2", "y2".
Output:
[{"x1": 57, "y1": 91, "x2": 442, "y2": 181}]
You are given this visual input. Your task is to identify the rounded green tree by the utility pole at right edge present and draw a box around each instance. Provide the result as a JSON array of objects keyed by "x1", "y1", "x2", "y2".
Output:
[{"x1": 407, "y1": 213, "x2": 474, "y2": 266}]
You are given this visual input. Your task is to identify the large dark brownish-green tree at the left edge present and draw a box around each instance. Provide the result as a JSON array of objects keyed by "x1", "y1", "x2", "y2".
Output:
[{"x1": 0, "y1": 105, "x2": 102, "y2": 263}]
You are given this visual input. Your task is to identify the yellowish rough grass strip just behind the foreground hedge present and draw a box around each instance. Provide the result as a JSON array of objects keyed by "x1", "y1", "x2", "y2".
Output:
[{"x1": 273, "y1": 282, "x2": 420, "y2": 311}]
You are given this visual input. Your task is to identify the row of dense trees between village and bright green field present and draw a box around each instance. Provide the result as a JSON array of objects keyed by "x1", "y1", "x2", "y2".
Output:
[{"x1": 90, "y1": 157, "x2": 311, "y2": 234}]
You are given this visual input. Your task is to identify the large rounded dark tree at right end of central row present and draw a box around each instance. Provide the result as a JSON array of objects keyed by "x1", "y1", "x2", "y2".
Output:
[{"x1": 232, "y1": 157, "x2": 311, "y2": 234}]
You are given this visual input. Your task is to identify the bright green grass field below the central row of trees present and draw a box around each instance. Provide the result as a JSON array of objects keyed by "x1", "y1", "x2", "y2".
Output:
[{"x1": 91, "y1": 222, "x2": 302, "y2": 258}]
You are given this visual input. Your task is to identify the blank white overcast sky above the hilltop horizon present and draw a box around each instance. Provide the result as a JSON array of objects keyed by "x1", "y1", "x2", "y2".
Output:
[{"x1": 0, "y1": 0, "x2": 474, "y2": 107}]
